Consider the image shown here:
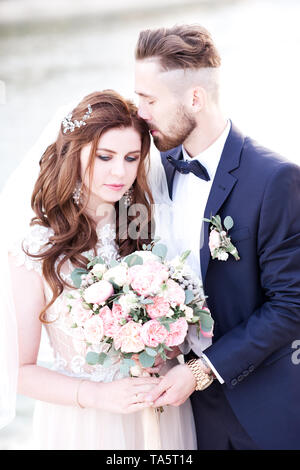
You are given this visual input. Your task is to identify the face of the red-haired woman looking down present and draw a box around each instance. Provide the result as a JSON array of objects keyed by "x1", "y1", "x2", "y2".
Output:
[{"x1": 80, "y1": 127, "x2": 142, "y2": 209}]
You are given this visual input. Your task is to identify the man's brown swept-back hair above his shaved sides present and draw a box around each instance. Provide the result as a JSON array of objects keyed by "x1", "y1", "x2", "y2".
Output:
[{"x1": 135, "y1": 24, "x2": 221, "y2": 71}]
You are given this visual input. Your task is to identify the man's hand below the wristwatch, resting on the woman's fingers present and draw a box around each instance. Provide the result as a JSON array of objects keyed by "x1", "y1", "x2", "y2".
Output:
[{"x1": 146, "y1": 364, "x2": 196, "y2": 408}]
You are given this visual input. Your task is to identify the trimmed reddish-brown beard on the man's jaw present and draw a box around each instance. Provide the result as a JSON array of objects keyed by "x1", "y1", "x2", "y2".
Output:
[{"x1": 149, "y1": 106, "x2": 197, "y2": 152}]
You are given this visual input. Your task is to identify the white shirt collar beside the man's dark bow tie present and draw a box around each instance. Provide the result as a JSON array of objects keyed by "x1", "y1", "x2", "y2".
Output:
[{"x1": 182, "y1": 120, "x2": 231, "y2": 180}]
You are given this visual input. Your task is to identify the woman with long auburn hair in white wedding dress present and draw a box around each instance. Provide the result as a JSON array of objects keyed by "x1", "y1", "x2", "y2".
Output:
[{"x1": 0, "y1": 90, "x2": 196, "y2": 450}]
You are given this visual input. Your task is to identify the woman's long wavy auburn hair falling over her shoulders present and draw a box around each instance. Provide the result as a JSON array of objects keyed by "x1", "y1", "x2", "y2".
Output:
[{"x1": 27, "y1": 90, "x2": 153, "y2": 323}]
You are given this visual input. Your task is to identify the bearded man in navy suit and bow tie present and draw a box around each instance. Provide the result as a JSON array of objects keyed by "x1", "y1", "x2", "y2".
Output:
[{"x1": 135, "y1": 25, "x2": 300, "y2": 449}]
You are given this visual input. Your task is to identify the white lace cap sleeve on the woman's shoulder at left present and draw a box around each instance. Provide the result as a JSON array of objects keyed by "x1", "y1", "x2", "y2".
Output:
[{"x1": 8, "y1": 225, "x2": 54, "y2": 275}]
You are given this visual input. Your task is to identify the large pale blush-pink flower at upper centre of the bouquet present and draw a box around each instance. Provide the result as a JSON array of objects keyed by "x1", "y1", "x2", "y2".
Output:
[{"x1": 128, "y1": 261, "x2": 168, "y2": 296}]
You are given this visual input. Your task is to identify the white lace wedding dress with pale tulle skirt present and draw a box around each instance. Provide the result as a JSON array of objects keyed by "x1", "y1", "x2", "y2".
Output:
[{"x1": 11, "y1": 224, "x2": 196, "y2": 450}]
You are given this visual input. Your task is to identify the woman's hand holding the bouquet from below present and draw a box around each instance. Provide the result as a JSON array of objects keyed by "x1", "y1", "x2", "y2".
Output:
[{"x1": 86, "y1": 377, "x2": 161, "y2": 414}]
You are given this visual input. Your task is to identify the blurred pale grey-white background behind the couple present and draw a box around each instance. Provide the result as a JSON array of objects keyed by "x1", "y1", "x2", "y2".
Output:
[{"x1": 0, "y1": 0, "x2": 300, "y2": 449}]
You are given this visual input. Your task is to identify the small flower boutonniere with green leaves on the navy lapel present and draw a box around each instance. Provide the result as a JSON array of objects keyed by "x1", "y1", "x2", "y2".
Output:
[{"x1": 203, "y1": 215, "x2": 240, "y2": 261}]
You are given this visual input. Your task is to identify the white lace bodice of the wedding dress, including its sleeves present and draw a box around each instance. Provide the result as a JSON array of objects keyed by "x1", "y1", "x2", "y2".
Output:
[{"x1": 10, "y1": 224, "x2": 126, "y2": 382}]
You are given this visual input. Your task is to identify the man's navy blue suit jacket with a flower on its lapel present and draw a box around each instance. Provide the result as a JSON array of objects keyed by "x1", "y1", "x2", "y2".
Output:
[{"x1": 161, "y1": 125, "x2": 300, "y2": 449}]
